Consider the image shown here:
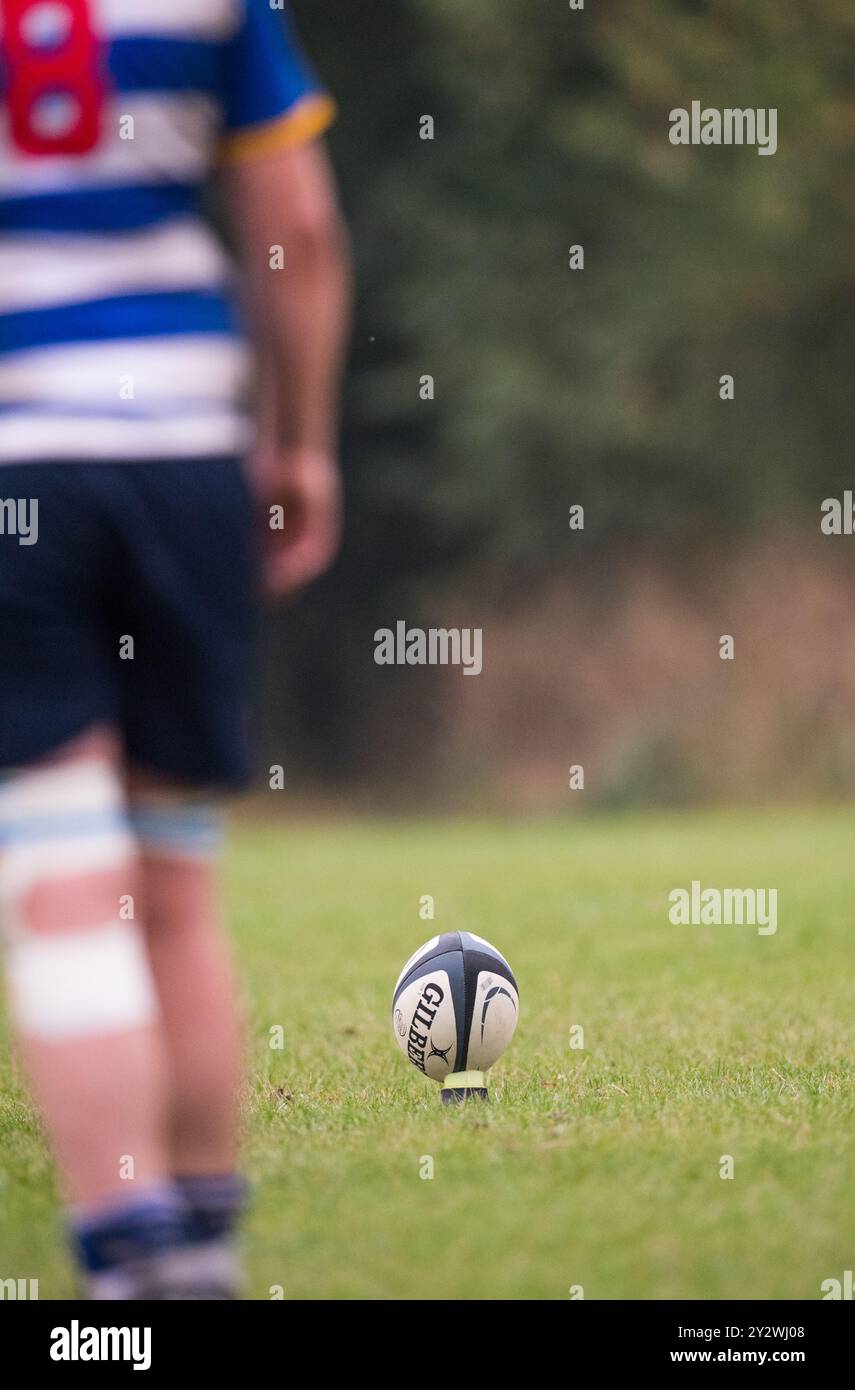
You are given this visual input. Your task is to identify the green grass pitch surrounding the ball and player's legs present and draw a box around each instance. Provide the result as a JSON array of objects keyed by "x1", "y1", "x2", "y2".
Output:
[{"x1": 0, "y1": 810, "x2": 855, "y2": 1300}]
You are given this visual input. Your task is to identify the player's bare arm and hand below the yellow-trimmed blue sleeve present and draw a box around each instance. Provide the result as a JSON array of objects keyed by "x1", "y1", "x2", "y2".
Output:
[{"x1": 224, "y1": 139, "x2": 350, "y2": 592}]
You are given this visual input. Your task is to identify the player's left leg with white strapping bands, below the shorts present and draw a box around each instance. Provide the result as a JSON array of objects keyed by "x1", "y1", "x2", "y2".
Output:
[{"x1": 0, "y1": 731, "x2": 184, "y2": 1297}]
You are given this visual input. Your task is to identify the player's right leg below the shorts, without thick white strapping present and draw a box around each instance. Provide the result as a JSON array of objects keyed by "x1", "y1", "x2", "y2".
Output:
[{"x1": 129, "y1": 773, "x2": 243, "y2": 1286}]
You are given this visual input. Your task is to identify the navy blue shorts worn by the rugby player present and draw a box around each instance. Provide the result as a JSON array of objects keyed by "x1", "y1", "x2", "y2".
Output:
[{"x1": 0, "y1": 459, "x2": 256, "y2": 787}]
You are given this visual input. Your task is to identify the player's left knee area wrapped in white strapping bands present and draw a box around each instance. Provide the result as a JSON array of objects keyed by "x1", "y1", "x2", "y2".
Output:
[{"x1": 0, "y1": 752, "x2": 156, "y2": 1040}]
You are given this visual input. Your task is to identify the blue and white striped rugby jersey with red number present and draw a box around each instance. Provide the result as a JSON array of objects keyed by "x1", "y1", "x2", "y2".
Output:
[{"x1": 0, "y1": 0, "x2": 334, "y2": 463}]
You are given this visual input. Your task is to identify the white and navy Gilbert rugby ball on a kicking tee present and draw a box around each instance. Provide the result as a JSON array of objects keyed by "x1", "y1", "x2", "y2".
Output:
[{"x1": 392, "y1": 931, "x2": 520, "y2": 1104}]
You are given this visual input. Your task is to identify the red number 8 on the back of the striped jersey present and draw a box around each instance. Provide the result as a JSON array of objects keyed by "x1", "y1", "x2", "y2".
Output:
[{"x1": 3, "y1": 0, "x2": 105, "y2": 154}]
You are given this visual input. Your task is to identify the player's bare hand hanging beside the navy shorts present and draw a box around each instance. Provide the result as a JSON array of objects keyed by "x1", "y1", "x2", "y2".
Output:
[{"x1": 259, "y1": 449, "x2": 342, "y2": 595}]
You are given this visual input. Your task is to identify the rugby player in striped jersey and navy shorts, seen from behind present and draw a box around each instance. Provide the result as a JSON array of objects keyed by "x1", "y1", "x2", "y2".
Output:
[{"x1": 0, "y1": 0, "x2": 349, "y2": 1300}]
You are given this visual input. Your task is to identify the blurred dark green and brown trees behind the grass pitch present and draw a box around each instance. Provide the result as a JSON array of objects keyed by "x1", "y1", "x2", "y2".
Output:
[{"x1": 257, "y1": 0, "x2": 855, "y2": 808}]
